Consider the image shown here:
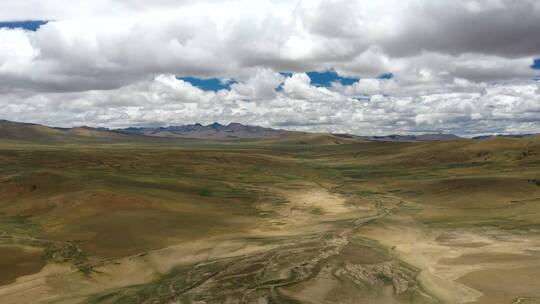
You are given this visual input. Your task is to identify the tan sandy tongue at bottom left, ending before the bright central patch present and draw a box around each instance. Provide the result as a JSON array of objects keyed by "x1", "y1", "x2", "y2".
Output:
[{"x1": 0, "y1": 236, "x2": 282, "y2": 304}]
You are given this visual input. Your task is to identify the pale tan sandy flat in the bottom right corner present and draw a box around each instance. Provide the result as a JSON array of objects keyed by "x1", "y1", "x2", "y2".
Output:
[{"x1": 360, "y1": 215, "x2": 540, "y2": 303}]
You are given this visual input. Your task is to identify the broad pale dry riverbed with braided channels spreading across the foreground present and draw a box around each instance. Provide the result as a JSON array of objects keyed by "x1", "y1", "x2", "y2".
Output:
[{"x1": 4, "y1": 183, "x2": 540, "y2": 304}]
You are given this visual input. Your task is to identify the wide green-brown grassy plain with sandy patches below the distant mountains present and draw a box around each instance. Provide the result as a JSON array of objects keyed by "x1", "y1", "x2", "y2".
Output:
[{"x1": 0, "y1": 134, "x2": 540, "y2": 303}]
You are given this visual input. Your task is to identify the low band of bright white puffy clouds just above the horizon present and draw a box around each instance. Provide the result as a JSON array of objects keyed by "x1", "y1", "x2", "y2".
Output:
[{"x1": 0, "y1": 71, "x2": 540, "y2": 135}]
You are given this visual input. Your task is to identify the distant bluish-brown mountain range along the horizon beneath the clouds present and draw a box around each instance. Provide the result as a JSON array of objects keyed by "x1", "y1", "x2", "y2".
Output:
[{"x1": 0, "y1": 120, "x2": 534, "y2": 143}]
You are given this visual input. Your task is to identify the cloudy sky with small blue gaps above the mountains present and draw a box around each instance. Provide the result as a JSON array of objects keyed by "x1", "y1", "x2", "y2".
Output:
[{"x1": 0, "y1": 0, "x2": 540, "y2": 136}]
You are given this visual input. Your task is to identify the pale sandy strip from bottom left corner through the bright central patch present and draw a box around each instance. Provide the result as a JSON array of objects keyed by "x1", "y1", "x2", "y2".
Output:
[{"x1": 0, "y1": 185, "x2": 361, "y2": 304}]
